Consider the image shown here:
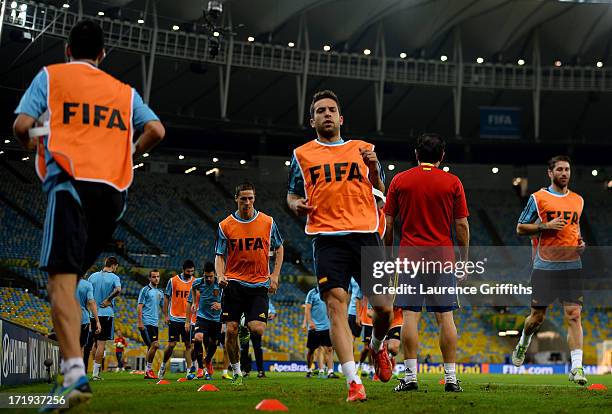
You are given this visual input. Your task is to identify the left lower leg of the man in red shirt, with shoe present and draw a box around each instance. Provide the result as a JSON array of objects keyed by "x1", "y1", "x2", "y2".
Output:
[{"x1": 395, "y1": 307, "x2": 421, "y2": 392}]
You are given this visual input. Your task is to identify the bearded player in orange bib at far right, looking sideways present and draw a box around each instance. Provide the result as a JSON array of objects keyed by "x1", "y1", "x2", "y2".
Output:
[{"x1": 512, "y1": 155, "x2": 587, "y2": 385}]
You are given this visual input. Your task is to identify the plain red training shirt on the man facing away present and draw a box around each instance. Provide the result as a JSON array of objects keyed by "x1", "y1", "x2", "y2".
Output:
[{"x1": 384, "y1": 163, "x2": 469, "y2": 246}]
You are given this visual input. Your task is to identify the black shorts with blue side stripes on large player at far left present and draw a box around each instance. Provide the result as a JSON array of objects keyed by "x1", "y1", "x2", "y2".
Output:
[{"x1": 40, "y1": 179, "x2": 127, "y2": 275}]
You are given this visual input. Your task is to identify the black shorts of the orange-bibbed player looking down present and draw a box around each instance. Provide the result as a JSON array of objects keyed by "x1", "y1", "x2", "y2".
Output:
[{"x1": 221, "y1": 280, "x2": 268, "y2": 323}]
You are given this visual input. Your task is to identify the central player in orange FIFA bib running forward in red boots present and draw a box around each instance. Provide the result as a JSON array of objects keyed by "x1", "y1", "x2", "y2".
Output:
[{"x1": 287, "y1": 91, "x2": 392, "y2": 401}]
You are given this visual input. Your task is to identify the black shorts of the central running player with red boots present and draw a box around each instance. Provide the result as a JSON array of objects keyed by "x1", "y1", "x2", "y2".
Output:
[{"x1": 313, "y1": 233, "x2": 385, "y2": 294}]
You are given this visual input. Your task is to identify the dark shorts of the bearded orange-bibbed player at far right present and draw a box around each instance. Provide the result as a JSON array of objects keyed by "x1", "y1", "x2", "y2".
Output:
[{"x1": 531, "y1": 269, "x2": 584, "y2": 308}]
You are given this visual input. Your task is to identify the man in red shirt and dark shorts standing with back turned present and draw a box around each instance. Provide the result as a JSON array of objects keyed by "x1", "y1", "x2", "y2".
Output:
[{"x1": 384, "y1": 134, "x2": 470, "y2": 392}]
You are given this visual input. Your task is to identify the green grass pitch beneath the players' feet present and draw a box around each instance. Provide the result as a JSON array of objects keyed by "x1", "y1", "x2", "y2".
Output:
[{"x1": 0, "y1": 373, "x2": 612, "y2": 414}]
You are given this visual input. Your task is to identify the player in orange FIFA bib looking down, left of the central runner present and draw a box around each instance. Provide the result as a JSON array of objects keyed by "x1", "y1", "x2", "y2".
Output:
[{"x1": 215, "y1": 183, "x2": 284, "y2": 385}]
